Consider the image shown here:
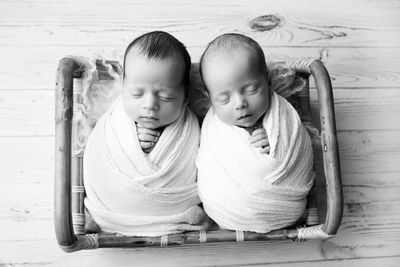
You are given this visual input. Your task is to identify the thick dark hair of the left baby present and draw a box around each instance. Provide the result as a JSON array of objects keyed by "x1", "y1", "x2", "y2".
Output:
[{"x1": 123, "y1": 31, "x2": 192, "y2": 96}]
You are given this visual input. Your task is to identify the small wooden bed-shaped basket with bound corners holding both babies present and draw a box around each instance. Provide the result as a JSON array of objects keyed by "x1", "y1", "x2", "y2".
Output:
[{"x1": 54, "y1": 57, "x2": 343, "y2": 252}]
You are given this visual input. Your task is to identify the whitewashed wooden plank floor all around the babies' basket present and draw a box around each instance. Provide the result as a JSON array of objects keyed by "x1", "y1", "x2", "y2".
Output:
[{"x1": 0, "y1": 0, "x2": 400, "y2": 266}]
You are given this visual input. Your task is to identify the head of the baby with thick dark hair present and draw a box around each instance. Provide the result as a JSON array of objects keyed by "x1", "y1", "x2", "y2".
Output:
[{"x1": 122, "y1": 31, "x2": 191, "y2": 129}]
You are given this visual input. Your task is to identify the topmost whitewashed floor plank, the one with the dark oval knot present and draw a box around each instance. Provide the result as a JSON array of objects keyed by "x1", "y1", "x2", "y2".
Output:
[{"x1": 0, "y1": 0, "x2": 400, "y2": 47}]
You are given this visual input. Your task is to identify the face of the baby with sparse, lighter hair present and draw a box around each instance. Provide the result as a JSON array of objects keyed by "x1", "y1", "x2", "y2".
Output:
[{"x1": 203, "y1": 49, "x2": 269, "y2": 127}]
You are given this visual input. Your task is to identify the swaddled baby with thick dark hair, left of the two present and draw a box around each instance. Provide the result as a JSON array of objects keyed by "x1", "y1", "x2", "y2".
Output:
[{"x1": 84, "y1": 32, "x2": 208, "y2": 236}]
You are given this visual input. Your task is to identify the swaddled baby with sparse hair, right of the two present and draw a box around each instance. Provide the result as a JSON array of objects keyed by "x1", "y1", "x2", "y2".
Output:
[{"x1": 197, "y1": 34, "x2": 314, "y2": 233}]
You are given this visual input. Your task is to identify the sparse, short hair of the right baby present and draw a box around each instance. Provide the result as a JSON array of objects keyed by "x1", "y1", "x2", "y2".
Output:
[{"x1": 199, "y1": 33, "x2": 269, "y2": 87}]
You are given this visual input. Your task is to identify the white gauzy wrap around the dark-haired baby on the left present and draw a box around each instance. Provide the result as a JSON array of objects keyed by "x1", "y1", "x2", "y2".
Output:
[{"x1": 84, "y1": 99, "x2": 207, "y2": 236}]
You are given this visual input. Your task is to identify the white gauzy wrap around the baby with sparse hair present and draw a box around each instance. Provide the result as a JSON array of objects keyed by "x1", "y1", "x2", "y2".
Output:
[{"x1": 197, "y1": 93, "x2": 314, "y2": 233}]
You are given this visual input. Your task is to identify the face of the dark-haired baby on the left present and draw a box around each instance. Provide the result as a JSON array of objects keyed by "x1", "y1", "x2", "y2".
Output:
[{"x1": 122, "y1": 51, "x2": 185, "y2": 129}]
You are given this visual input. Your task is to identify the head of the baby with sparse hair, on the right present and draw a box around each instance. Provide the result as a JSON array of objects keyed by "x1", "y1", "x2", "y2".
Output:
[{"x1": 200, "y1": 33, "x2": 272, "y2": 127}]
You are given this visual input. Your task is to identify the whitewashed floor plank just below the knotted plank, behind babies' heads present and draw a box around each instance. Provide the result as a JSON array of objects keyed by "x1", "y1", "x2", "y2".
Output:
[{"x1": 0, "y1": 47, "x2": 400, "y2": 90}]
